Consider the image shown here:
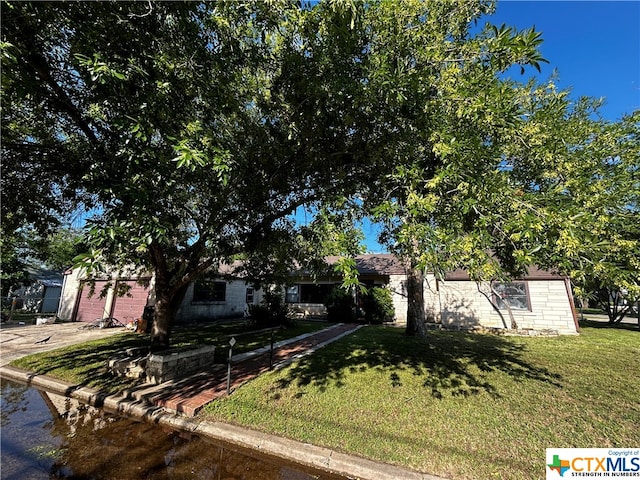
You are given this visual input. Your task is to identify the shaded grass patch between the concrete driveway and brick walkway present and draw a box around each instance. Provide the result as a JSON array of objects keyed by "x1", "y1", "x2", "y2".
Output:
[{"x1": 11, "y1": 321, "x2": 328, "y2": 392}]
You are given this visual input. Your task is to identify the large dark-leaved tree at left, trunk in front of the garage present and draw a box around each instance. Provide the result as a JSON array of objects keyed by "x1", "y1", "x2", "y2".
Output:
[{"x1": 2, "y1": 1, "x2": 392, "y2": 348}]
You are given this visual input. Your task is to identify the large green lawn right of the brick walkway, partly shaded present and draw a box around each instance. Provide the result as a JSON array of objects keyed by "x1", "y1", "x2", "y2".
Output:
[{"x1": 201, "y1": 322, "x2": 640, "y2": 479}]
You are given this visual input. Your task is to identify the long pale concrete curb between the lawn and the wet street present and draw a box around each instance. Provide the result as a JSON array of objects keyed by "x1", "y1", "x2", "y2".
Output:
[{"x1": 0, "y1": 364, "x2": 444, "y2": 480}]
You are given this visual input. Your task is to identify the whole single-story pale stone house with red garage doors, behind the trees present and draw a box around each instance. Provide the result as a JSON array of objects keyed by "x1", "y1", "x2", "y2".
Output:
[{"x1": 58, "y1": 254, "x2": 578, "y2": 334}]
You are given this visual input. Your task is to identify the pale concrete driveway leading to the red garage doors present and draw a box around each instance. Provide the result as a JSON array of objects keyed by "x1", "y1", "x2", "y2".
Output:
[{"x1": 0, "y1": 322, "x2": 125, "y2": 366}]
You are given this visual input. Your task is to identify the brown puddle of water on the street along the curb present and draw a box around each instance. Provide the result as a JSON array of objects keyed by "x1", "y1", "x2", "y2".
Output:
[{"x1": 0, "y1": 380, "x2": 344, "y2": 480}]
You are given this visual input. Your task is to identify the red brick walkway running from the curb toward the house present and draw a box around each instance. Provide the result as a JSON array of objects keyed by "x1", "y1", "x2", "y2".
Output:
[{"x1": 134, "y1": 324, "x2": 359, "y2": 416}]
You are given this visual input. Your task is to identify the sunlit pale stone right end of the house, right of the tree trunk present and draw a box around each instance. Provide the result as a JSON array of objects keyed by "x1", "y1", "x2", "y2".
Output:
[{"x1": 424, "y1": 267, "x2": 578, "y2": 334}]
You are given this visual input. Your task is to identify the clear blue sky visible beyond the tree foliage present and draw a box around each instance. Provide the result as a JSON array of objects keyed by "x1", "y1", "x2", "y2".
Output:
[{"x1": 363, "y1": 0, "x2": 640, "y2": 252}]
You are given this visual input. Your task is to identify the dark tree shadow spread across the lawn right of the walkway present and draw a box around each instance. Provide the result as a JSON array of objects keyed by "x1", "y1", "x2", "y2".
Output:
[{"x1": 274, "y1": 327, "x2": 562, "y2": 398}]
